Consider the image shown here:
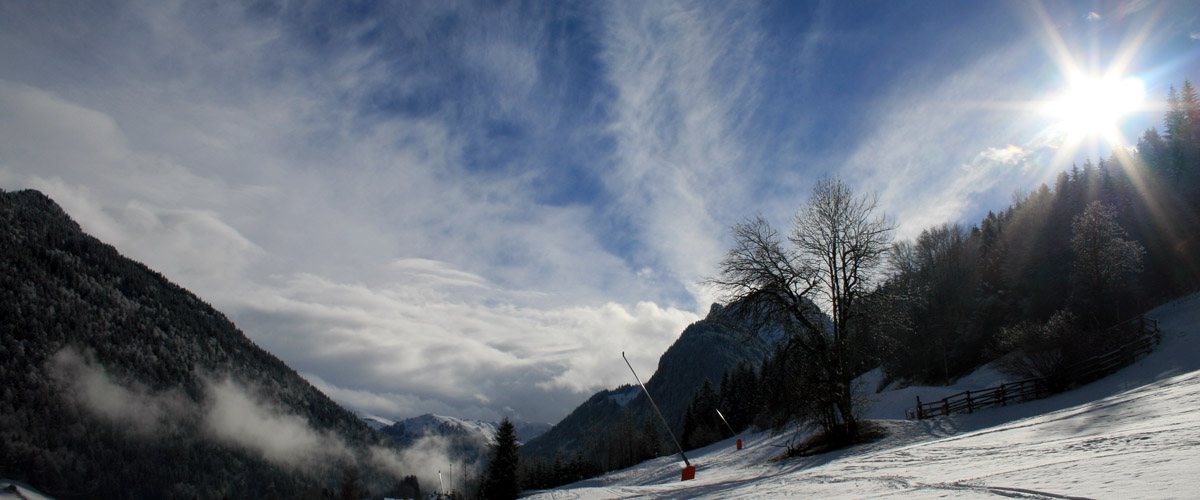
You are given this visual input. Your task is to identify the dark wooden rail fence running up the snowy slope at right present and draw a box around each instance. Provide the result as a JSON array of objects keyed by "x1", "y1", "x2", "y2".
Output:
[{"x1": 905, "y1": 317, "x2": 1162, "y2": 420}]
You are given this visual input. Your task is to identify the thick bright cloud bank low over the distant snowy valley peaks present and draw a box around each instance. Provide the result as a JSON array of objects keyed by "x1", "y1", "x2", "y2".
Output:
[{"x1": 236, "y1": 268, "x2": 698, "y2": 421}]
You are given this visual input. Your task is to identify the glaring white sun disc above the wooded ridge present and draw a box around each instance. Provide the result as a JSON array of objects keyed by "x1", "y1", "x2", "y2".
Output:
[{"x1": 1045, "y1": 73, "x2": 1146, "y2": 137}]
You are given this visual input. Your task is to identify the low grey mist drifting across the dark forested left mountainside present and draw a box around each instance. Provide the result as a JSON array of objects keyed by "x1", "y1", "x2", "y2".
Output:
[{"x1": 48, "y1": 348, "x2": 480, "y2": 490}]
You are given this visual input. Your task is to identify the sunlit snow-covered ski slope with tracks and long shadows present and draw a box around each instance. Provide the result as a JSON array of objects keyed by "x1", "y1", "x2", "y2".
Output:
[{"x1": 533, "y1": 295, "x2": 1200, "y2": 499}]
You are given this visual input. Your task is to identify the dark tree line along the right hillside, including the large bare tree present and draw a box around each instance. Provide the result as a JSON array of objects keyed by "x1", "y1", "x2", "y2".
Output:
[{"x1": 689, "y1": 82, "x2": 1200, "y2": 446}]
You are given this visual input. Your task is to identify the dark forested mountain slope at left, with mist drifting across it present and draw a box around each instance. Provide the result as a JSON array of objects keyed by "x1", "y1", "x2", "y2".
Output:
[{"x1": 0, "y1": 191, "x2": 417, "y2": 499}]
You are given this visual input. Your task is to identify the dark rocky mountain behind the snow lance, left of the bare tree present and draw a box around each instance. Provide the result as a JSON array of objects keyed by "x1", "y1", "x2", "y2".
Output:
[{"x1": 522, "y1": 299, "x2": 782, "y2": 460}]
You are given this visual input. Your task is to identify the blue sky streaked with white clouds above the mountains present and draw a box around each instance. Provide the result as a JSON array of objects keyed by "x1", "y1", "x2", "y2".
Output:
[{"x1": 0, "y1": 0, "x2": 1200, "y2": 422}]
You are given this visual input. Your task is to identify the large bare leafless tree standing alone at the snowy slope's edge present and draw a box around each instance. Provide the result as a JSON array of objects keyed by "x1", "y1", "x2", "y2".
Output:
[{"x1": 708, "y1": 179, "x2": 893, "y2": 441}]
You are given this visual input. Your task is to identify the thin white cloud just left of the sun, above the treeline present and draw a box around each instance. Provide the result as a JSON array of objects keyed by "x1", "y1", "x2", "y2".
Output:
[{"x1": 839, "y1": 41, "x2": 1065, "y2": 239}]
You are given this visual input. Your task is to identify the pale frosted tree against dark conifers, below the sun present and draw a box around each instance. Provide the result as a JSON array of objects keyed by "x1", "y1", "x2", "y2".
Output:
[{"x1": 1070, "y1": 201, "x2": 1146, "y2": 323}]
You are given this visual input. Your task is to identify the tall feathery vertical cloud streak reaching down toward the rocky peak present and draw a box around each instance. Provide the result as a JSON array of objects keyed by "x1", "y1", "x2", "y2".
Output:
[{"x1": 604, "y1": 2, "x2": 762, "y2": 309}]
